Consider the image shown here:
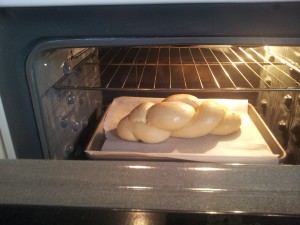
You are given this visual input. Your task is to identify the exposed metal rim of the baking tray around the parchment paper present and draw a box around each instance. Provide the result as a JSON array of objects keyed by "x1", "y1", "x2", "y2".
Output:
[{"x1": 85, "y1": 96, "x2": 286, "y2": 164}]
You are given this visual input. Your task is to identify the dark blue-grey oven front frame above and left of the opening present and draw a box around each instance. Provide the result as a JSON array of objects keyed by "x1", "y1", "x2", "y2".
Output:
[{"x1": 0, "y1": 3, "x2": 300, "y2": 158}]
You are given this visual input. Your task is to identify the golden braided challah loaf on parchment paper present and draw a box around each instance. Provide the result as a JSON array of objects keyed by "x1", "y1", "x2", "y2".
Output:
[{"x1": 117, "y1": 94, "x2": 241, "y2": 143}]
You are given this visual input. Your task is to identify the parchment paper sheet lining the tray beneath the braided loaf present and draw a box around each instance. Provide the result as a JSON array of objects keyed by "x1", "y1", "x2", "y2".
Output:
[{"x1": 95, "y1": 97, "x2": 278, "y2": 164}]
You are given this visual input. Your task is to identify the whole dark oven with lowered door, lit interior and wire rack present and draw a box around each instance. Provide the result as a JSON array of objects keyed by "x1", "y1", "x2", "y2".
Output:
[{"x1": 0, "y1": 1, "x2": 300, "y2": 224}]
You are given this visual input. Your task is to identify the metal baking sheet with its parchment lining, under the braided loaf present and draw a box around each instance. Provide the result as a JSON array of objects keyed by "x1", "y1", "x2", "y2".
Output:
[{"x1": 86, "y1": 97, "x2": 285, "y2": 164}]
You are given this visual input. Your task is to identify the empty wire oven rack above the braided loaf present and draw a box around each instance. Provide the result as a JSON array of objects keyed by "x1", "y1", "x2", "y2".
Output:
[{"x1": 54, "y1": 47, "x2": 300, "y2": 92}]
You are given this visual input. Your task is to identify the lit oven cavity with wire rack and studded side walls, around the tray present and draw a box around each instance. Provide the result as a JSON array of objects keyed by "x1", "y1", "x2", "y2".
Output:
[{"x1": 27, "y1": 45, "x2": 300, "y2": 164}]
